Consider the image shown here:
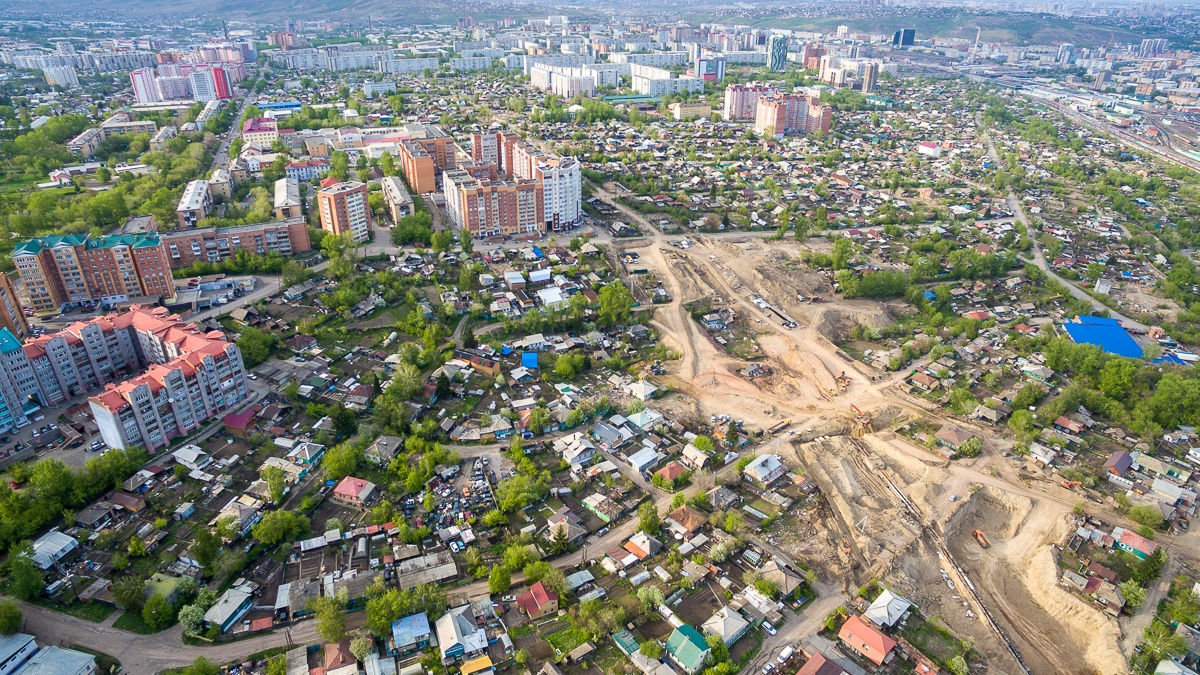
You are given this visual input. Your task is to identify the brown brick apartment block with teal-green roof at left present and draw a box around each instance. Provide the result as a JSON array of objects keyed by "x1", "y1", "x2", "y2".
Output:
[{"x1": 12, "y1": 233, "x2": 174, "y2": 311}]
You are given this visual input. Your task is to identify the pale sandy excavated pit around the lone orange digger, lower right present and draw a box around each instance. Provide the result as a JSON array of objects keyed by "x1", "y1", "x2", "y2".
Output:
[{"x1": 946, "y1": 488, "x2": 1126, "y2": 675}]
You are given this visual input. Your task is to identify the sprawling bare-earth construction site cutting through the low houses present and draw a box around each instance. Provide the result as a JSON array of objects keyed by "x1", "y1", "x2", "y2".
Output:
[{"x1": 622, "y1": 229, "x2": 1142, "y2": 675}]
